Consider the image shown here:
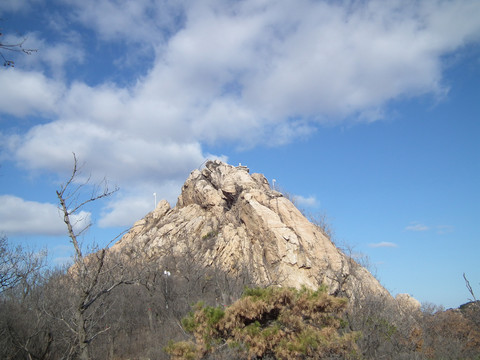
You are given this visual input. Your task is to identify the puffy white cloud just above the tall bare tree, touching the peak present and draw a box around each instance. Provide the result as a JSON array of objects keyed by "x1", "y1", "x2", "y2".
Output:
[{"x1": 16, "y1": 121, "x2": 204, "y2": 185}]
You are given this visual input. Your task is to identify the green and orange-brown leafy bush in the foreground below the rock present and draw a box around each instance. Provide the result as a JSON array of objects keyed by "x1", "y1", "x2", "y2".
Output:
[{"x1": 166, "y1": 287, "x2": 359, "y2": 359}]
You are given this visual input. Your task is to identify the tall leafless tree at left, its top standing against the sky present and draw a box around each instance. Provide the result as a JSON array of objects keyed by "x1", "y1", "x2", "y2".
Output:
[{"x1": 57, "y1": 154, "x2": 133, "y2": 360}]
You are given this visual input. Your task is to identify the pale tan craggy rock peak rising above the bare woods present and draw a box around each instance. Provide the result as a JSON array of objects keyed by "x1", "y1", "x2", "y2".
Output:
[{"x1": 113, "y1": 161, "x2": 390, "y2": 297}]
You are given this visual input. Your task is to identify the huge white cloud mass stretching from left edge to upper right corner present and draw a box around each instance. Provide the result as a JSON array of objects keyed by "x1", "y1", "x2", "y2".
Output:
[{"x1": 0, "y1": 0, "x2": 480, "y2": 230}]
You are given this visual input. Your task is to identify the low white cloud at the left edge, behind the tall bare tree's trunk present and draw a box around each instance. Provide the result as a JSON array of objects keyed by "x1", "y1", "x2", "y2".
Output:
[{"x1": 0, "y1": 195, "x2": 90, "y2": 236}]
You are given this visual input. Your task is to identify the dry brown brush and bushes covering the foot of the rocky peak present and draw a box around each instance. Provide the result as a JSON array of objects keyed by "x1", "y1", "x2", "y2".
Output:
[{"x1": 0, "y1": 242, "x2": 480, "y2": 360}]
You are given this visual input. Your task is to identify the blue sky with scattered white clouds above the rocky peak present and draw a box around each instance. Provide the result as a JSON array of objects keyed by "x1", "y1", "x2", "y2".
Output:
[{"x1": 0, "y1": 0, "x2": 480, "y2": 307}]
